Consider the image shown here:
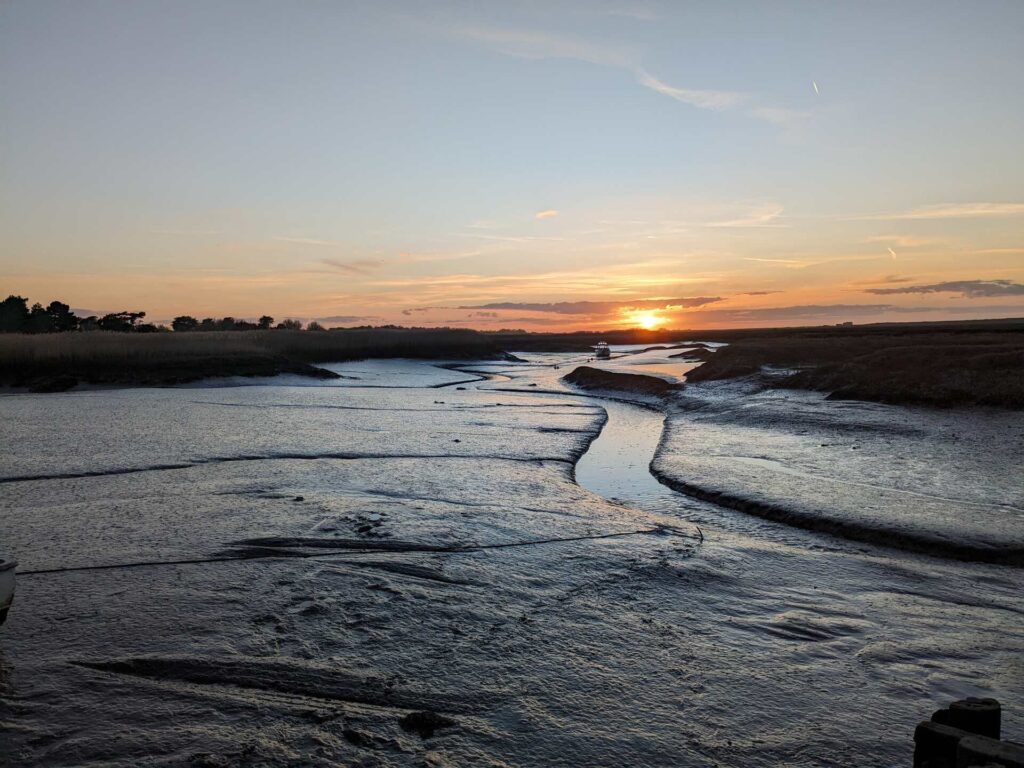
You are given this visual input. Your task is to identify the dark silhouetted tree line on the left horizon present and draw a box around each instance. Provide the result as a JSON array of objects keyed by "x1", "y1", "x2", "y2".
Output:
[{"x1": 0, "y1": 294, "x2": 326, "y2": 334}]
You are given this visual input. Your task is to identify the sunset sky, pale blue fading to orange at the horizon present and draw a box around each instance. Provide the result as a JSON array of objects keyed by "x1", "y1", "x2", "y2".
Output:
[{"x1": 0, "y1": 0, "x2": 1024, "y2": 331}]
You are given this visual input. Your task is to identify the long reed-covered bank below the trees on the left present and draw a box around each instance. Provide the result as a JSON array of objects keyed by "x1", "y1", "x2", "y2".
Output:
[{"x1": 0, "y1": 329, "x2": 501, "y2": 391}]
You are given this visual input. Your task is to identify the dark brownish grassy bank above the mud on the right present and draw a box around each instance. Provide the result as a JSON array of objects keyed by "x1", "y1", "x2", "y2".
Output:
[{"x1": 687, "y1": 330, "x2": 1024, "y2": 409}]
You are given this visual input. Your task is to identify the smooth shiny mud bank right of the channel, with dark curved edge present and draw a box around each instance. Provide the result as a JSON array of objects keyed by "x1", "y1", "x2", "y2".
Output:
[{"x1": 651, "y1": 384, "x2": 1024, "y2": 566}]
